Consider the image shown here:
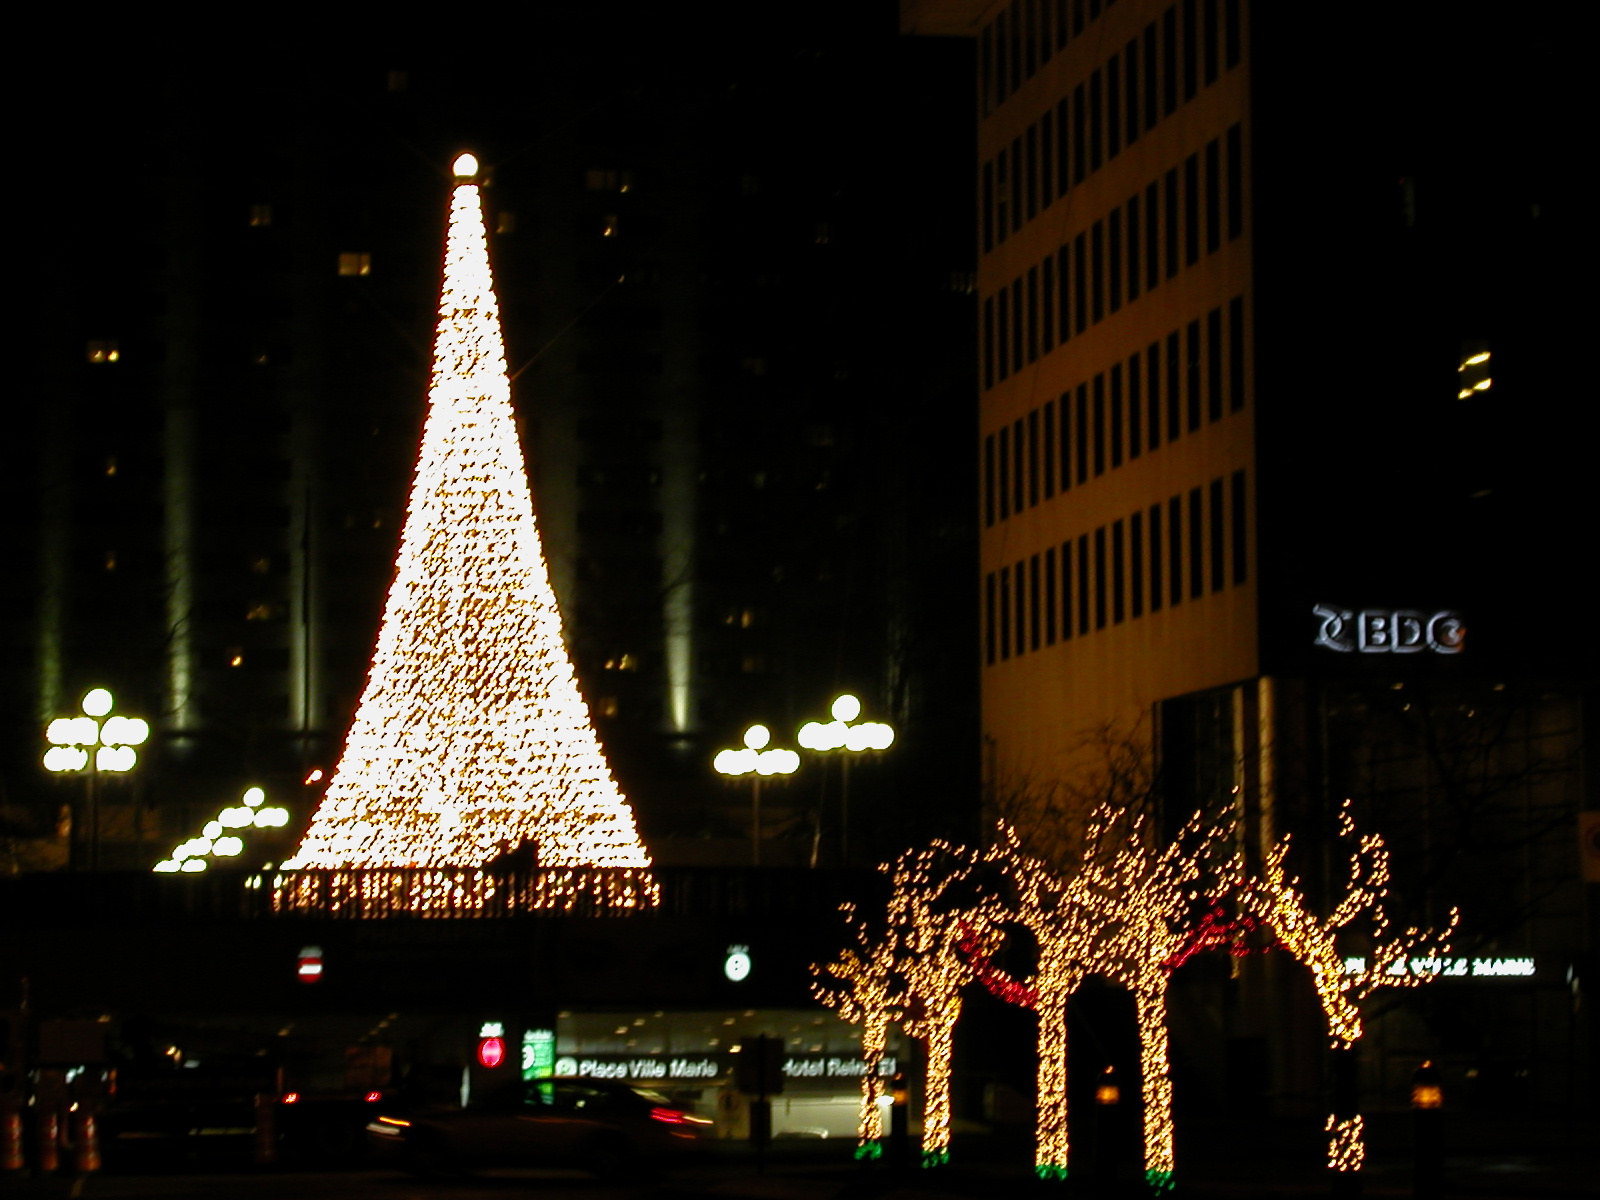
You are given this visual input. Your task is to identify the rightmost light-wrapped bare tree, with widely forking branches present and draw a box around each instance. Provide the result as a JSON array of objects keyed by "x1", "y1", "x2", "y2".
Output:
[{"x1": 1235, "y1": 802, "x2": 1459, "y2": 1176}]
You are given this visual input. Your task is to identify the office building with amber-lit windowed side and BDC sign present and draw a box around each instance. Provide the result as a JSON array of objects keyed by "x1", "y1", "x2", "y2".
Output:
[{"x1": 901, "y1": 0, "x2": 1597, "y2": 1139}]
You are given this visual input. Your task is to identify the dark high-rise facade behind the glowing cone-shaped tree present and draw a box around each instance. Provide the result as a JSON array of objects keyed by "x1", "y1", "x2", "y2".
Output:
[{"x1": 0, "y1": 6, "x2": 976, "y2": 869}]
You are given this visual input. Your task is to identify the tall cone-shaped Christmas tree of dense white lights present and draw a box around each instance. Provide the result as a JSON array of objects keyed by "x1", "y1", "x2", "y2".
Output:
[{"x1": 280, "y1": 155, "x2": 656, "y2": 912}]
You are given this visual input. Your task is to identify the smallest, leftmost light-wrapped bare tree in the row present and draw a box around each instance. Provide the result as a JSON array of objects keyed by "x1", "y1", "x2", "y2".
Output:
[{"x1": 811, "y1": 904, "x2": 904, "y2": 1158}]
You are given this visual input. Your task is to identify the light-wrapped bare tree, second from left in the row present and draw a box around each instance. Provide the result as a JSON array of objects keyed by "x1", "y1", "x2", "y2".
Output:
[{"x1": 888, "y1": 842, "x2": 1005, "y2": 1166}]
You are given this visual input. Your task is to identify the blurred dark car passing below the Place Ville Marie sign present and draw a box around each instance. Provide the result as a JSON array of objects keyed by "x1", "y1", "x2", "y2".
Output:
[{"x1": 366, "y1": 1078, "x2": 712, "y2": 1178}]
